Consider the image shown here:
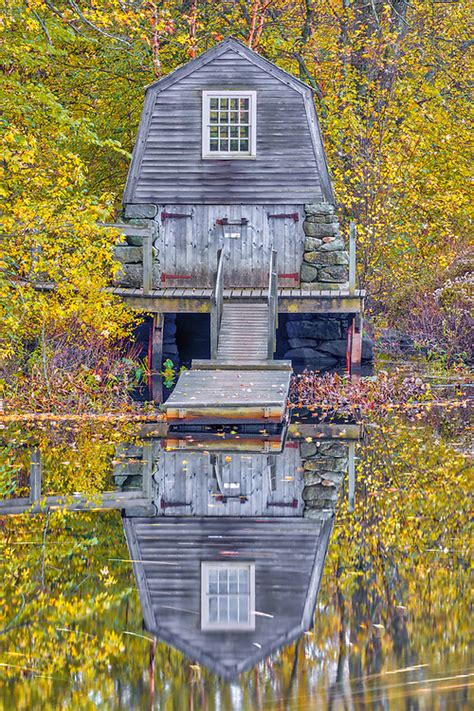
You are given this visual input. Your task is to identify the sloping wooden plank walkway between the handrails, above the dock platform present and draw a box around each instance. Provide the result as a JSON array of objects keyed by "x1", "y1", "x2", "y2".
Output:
[{"x1": 217, "y1": 302, "x2": 268, "y2": 363}]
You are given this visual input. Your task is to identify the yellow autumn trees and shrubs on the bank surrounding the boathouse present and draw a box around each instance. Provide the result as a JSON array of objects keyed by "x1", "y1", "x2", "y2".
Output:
[{"x1": 0, "y1": 0, "x2": 474, "y2": 414}]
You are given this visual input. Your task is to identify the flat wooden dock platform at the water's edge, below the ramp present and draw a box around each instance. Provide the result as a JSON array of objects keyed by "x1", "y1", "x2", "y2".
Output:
[{"x1": 163, "y1": 361, "x2": 291, "y2": 424}]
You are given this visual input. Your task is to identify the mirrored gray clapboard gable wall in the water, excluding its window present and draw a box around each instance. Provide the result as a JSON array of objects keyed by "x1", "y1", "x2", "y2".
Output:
[{"x1": 124, "y1": 513, "x2": 333, "y2": 678}]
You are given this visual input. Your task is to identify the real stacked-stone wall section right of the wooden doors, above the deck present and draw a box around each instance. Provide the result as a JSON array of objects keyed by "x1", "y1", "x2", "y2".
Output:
[{"x1": 301, "y1": 203, "x2": 349, "y2": 290}]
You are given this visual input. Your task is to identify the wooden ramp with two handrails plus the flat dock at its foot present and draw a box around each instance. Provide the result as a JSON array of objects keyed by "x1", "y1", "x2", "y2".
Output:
[{"x1": 164, "y1": 252, "x2": 291, "y2": 424}]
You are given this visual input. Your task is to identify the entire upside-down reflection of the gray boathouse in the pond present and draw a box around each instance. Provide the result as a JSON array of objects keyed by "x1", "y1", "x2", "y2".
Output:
[{"x1": 124, "y1": 426, "x2": 353, "y2": 679}]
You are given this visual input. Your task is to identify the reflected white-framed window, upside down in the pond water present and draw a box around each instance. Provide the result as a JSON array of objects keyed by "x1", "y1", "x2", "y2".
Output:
[{"x1": 201, "y1": 561, "x2": 255, "y2": 631}]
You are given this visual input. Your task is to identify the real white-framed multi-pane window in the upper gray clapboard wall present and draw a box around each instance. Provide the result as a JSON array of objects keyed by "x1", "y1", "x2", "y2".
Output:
[{"x1": 202, "y1": 91, "x2": 257, "y2": 160}]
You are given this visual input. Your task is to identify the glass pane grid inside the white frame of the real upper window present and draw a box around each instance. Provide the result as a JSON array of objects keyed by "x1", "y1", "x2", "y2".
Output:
[{"x1": 207, "y1": 96, "x2": 250, "y2": 153}]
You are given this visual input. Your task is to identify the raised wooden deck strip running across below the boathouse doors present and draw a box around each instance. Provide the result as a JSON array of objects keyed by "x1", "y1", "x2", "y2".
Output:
[{"x1": 111, "y1": 287, "x2": 365, "y2": 313}]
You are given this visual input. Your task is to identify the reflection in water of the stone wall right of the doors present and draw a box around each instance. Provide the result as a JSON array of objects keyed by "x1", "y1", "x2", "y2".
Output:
[{"x1": 300, "y1": 440, "x2": 349, "y2": 518}]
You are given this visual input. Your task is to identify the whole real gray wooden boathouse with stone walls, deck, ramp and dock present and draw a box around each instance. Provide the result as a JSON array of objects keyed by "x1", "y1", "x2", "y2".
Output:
[{"x1": 113, "y1": 38, "x2": 364, "y2": 422}]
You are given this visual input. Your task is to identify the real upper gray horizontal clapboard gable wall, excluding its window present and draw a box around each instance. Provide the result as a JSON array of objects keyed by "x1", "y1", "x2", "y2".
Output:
[{"x1": 124, "y1": 49, "x2": 323, "y2": 205}]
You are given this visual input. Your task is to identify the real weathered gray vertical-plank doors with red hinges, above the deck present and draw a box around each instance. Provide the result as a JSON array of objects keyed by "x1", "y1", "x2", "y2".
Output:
[{"x1": 155, "y1": 203, "x2": 304, "y2": 288}]
